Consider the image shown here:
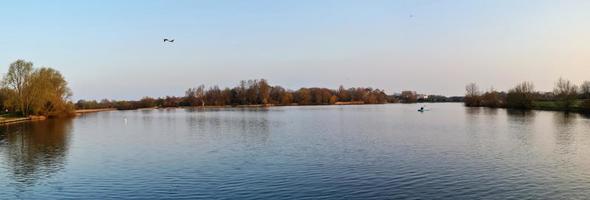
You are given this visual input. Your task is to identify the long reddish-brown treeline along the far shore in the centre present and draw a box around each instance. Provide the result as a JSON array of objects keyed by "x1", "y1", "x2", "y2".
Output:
[{"x1": 75, "y1": 79, "x2": 395, "y2": 110}]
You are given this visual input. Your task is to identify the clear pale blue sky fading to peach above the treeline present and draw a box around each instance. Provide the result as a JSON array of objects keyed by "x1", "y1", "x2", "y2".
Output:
[{"x1": 0, "y1": 0, "x2": 590, "y2": 99}]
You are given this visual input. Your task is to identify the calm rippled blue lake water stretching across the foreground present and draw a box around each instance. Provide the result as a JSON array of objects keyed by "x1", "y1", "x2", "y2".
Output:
[{"x1": 0, "y1": 104, "x2": 590, "y2": 199}]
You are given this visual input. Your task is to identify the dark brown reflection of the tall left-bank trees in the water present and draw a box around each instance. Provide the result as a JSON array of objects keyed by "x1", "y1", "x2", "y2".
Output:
[{"x1": 0, "y1": 119, "x2": 72, "y2": 186}]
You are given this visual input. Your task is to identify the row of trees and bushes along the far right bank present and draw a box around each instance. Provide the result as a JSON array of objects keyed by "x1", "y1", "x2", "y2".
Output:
[{"x1": 465, "y1": 78, "x2": 590, "y2": 112}]
